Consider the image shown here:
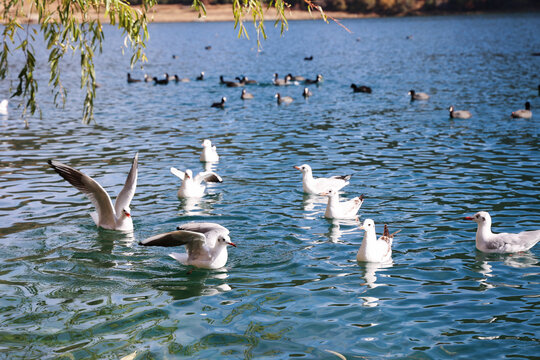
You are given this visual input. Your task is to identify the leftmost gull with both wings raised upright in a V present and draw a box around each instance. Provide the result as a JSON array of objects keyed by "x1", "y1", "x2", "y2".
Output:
[{"x1": 48, "y1": 153, "x2": 139, "y2": 231}]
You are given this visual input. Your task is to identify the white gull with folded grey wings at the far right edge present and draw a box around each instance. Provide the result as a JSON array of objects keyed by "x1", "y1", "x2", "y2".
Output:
[{"x1": 463, "y1": 211, "x2": 540, "y2": 254}]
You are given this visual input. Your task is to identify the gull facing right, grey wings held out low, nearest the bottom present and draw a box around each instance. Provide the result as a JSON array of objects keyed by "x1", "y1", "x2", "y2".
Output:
[{"x1": 140, "y1": 222, "x2": 236, "y2": 269}]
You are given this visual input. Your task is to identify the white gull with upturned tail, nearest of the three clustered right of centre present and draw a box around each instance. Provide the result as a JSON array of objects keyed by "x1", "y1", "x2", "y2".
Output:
[{"x1": 356, "y1": 219, "x2": 401, "y2": 263}]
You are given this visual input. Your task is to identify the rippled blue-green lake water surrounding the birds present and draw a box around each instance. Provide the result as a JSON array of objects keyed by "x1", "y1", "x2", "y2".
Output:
[{"x1": 0, "y1": 14, "x2": 540, "y2": 359}]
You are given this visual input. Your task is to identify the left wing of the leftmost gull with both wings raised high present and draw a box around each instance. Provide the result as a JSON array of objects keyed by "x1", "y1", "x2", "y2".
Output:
[{"x1": 48, "y1": 160, "x2": 116, "y2": 228}]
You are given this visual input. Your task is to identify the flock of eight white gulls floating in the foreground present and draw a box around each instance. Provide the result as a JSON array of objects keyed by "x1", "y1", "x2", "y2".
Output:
[{"x1": 48, "y1": 139, "x2": 540, "y2": 269}]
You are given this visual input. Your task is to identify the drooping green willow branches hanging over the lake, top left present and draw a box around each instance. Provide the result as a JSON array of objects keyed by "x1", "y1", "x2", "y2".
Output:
[{"x1": 0, "y1": 0, "x2": 296, "y2": 125}]
